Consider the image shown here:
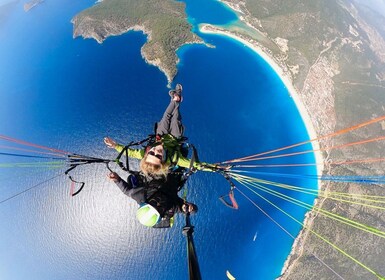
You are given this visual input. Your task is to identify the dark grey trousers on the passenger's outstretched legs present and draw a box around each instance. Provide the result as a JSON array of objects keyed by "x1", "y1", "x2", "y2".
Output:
[{"x1": 156, "y1": 100, "x2": 184, "y2": 138}]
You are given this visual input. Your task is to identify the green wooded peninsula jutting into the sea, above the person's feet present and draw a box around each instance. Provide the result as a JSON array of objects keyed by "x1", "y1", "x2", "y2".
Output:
[{"x1": 73, "y1": 0, "x2": 202, "y2": 81}]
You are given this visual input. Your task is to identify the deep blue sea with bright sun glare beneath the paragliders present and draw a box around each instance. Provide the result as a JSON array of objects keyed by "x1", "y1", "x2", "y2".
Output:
[{"x1": 0, "y1": 0, "x2": 317, "y2": 280}]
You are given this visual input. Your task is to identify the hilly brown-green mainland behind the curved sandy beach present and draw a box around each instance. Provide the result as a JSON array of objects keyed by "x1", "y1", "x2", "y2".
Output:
[{"x1": 219, "y1": 0, "x2": 385, "y2": 279}]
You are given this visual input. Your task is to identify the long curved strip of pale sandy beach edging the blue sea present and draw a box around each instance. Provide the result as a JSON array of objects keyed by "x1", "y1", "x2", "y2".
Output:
[{"x1": 198, "y1": 24, "x2": 324, "y2": 279}]
